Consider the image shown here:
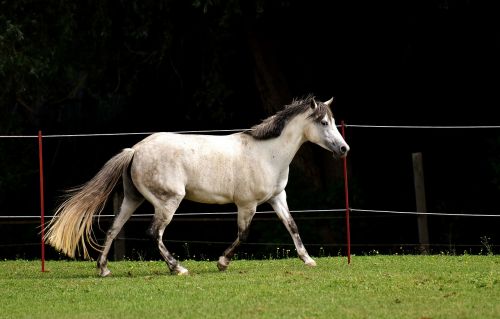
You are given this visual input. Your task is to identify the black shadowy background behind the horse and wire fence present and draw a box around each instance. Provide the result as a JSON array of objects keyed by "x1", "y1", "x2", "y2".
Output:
[{"x1": 0, "y1": 0, "x2": 500, "y2": 258}]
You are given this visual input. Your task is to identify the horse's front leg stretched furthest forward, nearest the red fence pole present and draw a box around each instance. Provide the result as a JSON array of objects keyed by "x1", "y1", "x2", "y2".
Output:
[{"x1": 268, "y1": 191, "x2": 316, "y2": 266}]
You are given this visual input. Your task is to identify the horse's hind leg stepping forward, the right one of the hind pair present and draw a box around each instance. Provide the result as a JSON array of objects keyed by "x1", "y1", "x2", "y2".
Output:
[{"x1": 150, "y1": 195, "x2": 189, "y2": 275}]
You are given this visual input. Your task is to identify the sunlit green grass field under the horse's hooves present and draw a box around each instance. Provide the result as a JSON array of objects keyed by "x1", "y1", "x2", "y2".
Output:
[{"x1": 0, "y1": 255, "x2": 500, "y2": 319}]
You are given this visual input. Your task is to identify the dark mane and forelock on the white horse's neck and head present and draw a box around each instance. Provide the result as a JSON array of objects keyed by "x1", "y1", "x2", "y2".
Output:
[{"x1": 244, "y1": 94, "x2": 332, "y2": 140}]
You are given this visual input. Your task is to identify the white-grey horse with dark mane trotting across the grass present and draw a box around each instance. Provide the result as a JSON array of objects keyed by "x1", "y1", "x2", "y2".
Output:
[{"x1": 46, "y1": 96, "x2": 349, "y2": 277}]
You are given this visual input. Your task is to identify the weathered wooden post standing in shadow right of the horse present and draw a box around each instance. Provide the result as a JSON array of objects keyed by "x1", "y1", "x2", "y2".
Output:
[{"x1": 412, "y1": 153, "x2": 429, "y2": 254}]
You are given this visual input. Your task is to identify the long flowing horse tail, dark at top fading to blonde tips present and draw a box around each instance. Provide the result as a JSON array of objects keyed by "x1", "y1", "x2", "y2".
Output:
[{"x1": 45, "y1": 148, "x2": 134, "y2": 259}]
